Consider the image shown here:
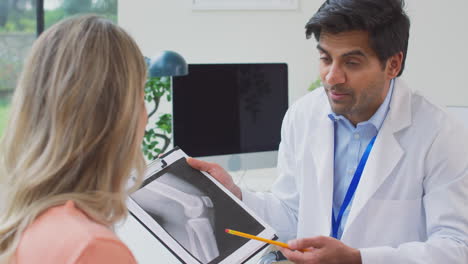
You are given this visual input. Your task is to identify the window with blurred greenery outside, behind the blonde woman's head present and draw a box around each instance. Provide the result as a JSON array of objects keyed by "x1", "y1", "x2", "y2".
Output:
[{"x1": 0, "y1": 0, "x2": 117, "y2": 135}]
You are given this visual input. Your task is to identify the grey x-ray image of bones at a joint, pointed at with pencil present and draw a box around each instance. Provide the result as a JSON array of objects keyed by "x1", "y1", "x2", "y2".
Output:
[{"x1": 131, "y1": 159, "x2": 264, "y2": 264}]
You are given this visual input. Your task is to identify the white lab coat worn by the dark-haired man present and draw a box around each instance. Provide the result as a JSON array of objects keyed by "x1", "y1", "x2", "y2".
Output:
[{"x1": 242, "y1": 79, "x2": 468, "y2": 264}]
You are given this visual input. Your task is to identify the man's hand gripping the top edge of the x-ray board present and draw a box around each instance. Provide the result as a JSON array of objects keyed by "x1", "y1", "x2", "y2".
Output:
[{"x1": 187, "y1": 157, "x2": 242, "y2": 200}]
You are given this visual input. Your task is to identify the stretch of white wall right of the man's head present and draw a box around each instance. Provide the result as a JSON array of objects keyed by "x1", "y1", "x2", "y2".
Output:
[{"x1": 404, "y1": 0, "x2": 468, "y2": 106}]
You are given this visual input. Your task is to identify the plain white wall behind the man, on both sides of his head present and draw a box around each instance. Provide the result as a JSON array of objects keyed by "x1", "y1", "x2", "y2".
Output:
[{"x1": 119, "y1": 0, "x2": 468, "y2": 106}]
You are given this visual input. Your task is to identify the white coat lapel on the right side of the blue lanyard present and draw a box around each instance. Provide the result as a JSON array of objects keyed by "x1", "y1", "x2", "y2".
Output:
[{"x1": 342, "y1": 79, "x2": 411, "y2": 240}]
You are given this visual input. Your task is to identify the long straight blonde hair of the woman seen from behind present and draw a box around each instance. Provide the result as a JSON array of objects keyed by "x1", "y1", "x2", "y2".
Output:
[{"x1": 0, "y1": 15, "x2": 146, "y2": 262}]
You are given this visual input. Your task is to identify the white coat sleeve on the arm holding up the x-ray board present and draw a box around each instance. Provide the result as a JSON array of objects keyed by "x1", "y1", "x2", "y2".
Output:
[{"x1": 242, "y1": 110, "x2": 299, "y2": 241}]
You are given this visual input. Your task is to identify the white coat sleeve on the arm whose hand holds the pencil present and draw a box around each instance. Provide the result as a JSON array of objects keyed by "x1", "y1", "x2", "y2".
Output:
[{"x1": 360, "y1": 124, "x2": 468, "y2": 264}]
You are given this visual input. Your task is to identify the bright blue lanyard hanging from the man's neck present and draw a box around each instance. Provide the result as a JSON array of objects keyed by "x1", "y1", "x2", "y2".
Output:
[{"x1": 332, "y1": 136, "x2": 377, "y2": 239}]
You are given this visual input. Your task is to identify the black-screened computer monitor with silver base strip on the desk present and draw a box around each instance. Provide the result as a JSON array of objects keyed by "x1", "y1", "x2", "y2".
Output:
[{"x1": 172, "y1": 63, "x2": 288, "y2": 171}]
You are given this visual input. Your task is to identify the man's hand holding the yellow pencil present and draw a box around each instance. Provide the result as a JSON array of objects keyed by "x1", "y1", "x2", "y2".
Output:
[{"x1": 280, "y1": 236, "x2": 362, "y2": 264}]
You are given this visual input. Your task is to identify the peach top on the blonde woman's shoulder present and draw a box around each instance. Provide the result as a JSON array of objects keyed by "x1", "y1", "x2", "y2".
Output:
[{"x1": 14, "y1": 201, "x2": 136, "y2": 264}]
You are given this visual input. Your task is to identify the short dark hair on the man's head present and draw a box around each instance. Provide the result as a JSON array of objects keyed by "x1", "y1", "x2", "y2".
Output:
[{"x1": 306, "y1": 0, "x2": 410, "y2": 76}]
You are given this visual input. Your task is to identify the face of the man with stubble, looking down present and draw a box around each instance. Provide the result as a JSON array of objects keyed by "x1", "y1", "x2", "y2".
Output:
[{"x1": 317, "y1": 31, "x2": 394, "y2": 125}]
